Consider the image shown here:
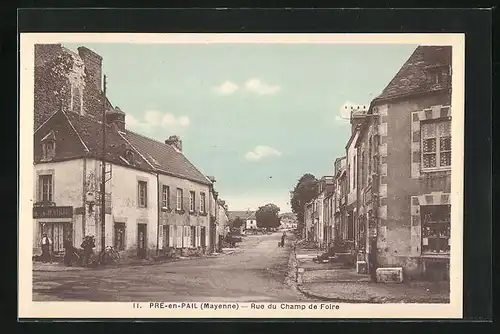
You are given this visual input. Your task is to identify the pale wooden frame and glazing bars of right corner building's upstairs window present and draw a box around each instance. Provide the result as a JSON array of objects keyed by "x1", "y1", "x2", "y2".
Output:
[{"x1": 420, "y1": 118, "x2": 452, "y2": 172}]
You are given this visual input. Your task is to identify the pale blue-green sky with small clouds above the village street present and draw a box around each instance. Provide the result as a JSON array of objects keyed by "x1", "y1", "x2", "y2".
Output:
[{"x1": 65, "y1": 44, "x2": 417, "y2": 212}]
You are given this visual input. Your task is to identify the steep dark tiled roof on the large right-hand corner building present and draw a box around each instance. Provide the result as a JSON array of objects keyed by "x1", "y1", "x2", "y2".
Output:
[{"x1": 375, "y1": 46, "x2": 451, "y2": 101}]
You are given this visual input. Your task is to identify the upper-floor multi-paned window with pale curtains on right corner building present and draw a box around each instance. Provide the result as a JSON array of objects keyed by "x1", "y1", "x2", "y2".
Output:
[{"x1": 421, "y1": 120, "x2": 451, "y2": 169}]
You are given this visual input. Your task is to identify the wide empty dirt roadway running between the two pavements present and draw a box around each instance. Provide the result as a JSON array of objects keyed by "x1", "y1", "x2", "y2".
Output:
[{"x1": 33, "y1": 233, "x2": 311, "y2": 302}]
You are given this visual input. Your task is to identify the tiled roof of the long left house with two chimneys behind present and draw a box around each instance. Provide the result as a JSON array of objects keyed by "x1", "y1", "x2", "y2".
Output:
[{"x1": 123, "y1": 130, "x2": 211, "y2": 184}]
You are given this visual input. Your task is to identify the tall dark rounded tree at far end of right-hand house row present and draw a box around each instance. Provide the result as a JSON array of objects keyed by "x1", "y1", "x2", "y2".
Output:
[{"x1": 291, "y1": 174, "x2": 318, "y2": 230}]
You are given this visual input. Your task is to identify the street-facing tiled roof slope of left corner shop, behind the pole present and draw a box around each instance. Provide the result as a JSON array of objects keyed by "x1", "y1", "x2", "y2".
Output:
[{"x1": 64, "y1": 112, "x2": 153, "y2": 171}]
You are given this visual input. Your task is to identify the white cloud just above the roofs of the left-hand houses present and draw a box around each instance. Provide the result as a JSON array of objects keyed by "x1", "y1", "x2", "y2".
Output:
[{"x1": 125, "y1": 110, "x2": 190, "y2": 132}]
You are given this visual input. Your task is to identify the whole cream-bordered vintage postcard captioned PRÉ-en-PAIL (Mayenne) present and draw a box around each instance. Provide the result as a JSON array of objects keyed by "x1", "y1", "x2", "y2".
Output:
[{"x1": 18, "y1": 33, "x2": 465, "y2": 319}]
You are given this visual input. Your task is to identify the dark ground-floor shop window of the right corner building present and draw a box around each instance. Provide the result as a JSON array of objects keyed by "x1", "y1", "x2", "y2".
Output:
[{"x1": 420, "y1": 205, "x2": 451, "y2": 254}]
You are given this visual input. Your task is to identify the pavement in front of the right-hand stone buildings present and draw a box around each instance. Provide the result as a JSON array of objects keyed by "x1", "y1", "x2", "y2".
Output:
[{"x1": 296, "y1": 247, "x2": 449, "y2": 303}]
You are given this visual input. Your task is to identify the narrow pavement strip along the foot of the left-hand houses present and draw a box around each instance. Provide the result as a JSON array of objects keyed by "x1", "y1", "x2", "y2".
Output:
[{"x1": 32, "y1": 248, "x2": 241, "y2": 272}]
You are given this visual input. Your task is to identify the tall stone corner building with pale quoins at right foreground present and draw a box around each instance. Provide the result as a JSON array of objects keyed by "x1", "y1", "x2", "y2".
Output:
[{"x1": 356, "y1": 46, "x2": 452, "y2": 279}]
